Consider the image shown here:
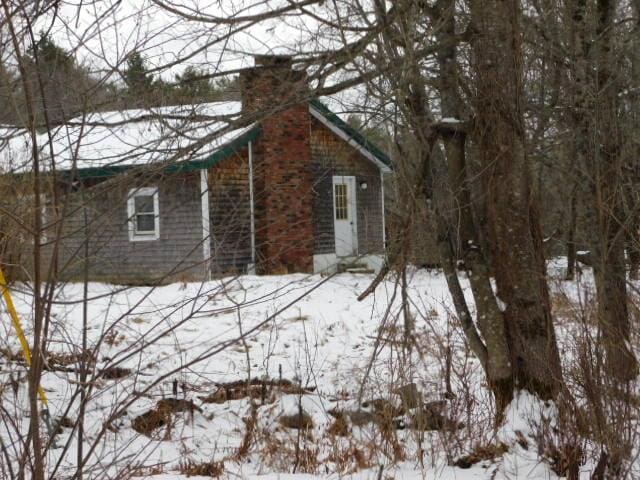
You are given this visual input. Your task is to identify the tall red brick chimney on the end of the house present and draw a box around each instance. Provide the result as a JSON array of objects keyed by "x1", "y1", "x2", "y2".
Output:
[{"x1": 240, "y1": 56, "x2": 314, "y2": 274}]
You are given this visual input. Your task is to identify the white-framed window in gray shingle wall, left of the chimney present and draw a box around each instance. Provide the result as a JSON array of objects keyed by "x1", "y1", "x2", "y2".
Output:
[{"x1": 127, "y1": 187, "x2": 160, "y2": 242}]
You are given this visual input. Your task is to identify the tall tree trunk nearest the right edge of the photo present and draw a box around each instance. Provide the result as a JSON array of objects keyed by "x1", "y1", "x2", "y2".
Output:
[{"x1": 587, "y1": 0, "x2": 638, "y2": 382}]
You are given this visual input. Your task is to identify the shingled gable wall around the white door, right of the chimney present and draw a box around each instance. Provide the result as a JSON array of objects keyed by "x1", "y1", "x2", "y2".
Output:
[{"x1": 311, "y1": 118, "x2": 384, "y2": 255}]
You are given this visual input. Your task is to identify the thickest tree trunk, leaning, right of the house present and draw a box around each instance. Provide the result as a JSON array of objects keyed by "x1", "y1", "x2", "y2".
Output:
[{"x1": 471, "y1": 0, "x2": 562, "y2": 398}]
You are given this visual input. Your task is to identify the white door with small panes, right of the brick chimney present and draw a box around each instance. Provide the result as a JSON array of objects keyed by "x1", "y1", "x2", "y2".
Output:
[{"x1": 333, "y1": 176, "x2": 358, "y2": 257}]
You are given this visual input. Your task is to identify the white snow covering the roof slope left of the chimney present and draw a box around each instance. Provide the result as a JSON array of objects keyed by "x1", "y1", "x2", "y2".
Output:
[{"x1": 0, "y1": 102, "x2": 253, "y2": 173}]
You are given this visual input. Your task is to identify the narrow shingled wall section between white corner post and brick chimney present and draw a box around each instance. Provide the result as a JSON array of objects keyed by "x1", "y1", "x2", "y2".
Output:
[{"x1": 209, "y1": 148, "x2": 252, "y2": 276}]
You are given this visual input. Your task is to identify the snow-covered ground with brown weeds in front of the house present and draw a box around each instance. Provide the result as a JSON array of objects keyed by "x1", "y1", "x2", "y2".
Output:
[{"x1": 0, "y1": 266, "x2": 636, "y2": 480}]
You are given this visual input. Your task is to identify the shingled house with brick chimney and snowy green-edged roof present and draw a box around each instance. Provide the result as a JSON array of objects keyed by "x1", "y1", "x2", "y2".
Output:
[{"x1": 0, "y1": 56, "x2": 391, "y2": 283}]
